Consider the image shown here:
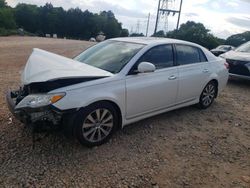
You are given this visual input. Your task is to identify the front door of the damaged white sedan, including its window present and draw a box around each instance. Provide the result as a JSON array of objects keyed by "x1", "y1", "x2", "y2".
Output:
[{"x1": 126, "y1": 45, "x2": 178, "y2": 119}]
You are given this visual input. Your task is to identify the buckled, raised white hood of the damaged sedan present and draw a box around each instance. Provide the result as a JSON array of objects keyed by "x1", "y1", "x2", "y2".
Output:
[{"x1": 22, "y1": 48, "x2": 113, "y2": 85}]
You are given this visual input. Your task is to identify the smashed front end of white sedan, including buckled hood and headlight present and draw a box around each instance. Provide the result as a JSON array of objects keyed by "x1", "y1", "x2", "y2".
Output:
[{"x1": 6, "y1": 49, "x2": 113, "y2": 140}]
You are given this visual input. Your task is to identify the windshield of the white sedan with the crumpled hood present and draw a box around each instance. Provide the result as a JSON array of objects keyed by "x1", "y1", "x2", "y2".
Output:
[{"x1": 74, "y1": 40, "x2": 144, "y2": 74}]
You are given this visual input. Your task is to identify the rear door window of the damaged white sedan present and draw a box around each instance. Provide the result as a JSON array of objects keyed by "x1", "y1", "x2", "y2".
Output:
[{"x1": 176, "y1": 44, "x2": 206, "y2": 65}]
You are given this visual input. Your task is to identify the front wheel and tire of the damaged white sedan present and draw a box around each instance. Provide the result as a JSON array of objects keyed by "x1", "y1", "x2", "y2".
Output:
[{"x1": 74, "y1": 102, "x2": 119, "y2": 147}]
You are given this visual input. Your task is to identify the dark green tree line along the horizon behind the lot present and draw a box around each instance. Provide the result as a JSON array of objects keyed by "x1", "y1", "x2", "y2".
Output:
[{"x1": 0, "y1": 0, "x2": 250, "y2": 49}]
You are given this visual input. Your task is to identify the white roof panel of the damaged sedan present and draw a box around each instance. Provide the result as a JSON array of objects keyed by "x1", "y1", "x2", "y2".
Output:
[{"x1": 110, "y1": 37, "x2": 201, "y2": 47}]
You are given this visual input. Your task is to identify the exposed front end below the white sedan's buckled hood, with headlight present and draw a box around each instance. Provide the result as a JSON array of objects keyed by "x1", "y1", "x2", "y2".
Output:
[{"x1": 6, "y1": 77, "x2": 103, "y2": 125}]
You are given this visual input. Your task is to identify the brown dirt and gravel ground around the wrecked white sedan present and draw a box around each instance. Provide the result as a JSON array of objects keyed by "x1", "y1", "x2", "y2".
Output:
[{"x1": 0, "y1": 37, "x2": 250, "y2": 188}]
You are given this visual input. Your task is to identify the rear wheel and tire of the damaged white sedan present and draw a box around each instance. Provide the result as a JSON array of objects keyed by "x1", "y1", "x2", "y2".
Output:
[{"x1": 199, "y1": 81, "x2": 217, "y2": 109}]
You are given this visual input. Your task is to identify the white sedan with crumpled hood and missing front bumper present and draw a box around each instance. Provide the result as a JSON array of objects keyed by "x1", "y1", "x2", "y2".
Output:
[{"x1": 7, "y1": 37, "x2": 228, "y2": 146}]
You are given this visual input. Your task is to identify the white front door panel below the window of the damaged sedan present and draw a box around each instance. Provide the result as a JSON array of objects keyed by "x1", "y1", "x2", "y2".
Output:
[{"x1": 126, "y1": 67, "x2": 178, "y2": 119}]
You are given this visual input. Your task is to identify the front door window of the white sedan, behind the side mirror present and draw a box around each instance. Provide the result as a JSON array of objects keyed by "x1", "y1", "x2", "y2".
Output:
[{"x1": 139, "y1": 45, "x2": 174, "y2": 69}]
